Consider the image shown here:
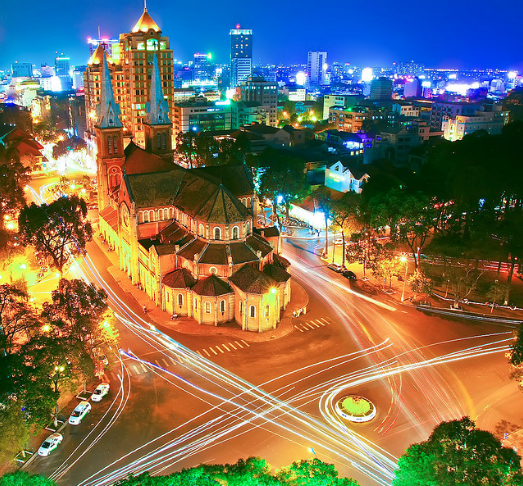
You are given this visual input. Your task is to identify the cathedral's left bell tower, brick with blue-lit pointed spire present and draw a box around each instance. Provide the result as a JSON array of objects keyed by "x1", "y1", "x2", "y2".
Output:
[{"x1": 94, "y1": 51, "x2": 125, "y2": 211}]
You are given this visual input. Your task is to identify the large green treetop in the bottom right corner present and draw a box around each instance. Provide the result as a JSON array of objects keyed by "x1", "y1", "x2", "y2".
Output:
[{"x1": 392, "y1": 417, "x2": 523, "y2": 486}]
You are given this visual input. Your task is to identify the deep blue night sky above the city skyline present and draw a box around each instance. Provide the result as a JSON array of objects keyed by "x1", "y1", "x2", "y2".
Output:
[{"x1": 0, "y1": 0, "x2": 523, "y2": 71}]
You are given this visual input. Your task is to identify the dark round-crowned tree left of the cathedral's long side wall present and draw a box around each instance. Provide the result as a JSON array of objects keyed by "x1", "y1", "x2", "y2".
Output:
[{"x1": 18, "y1": 196, "x2": 93, "y2": 273}]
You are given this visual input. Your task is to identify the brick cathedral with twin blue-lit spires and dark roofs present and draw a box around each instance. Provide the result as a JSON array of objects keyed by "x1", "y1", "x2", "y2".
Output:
[{"x1": 94, "y1": 47, "x2": 291, "y2": 332}]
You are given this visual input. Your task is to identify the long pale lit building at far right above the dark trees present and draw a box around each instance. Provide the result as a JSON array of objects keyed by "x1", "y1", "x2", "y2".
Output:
[{"x1": 441, "y1": 111, "x2": 508, "y2": 142}]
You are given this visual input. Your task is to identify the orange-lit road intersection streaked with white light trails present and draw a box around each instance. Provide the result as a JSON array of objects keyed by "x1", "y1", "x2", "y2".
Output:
[{"x1": 21, "y1": 173, "x2": 523, "y2": 486}]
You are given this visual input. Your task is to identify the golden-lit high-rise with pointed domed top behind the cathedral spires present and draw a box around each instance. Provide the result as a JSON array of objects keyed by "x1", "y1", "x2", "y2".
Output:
[{"x1": 84, "y1": 8, "x2": 174, "y2": 148}]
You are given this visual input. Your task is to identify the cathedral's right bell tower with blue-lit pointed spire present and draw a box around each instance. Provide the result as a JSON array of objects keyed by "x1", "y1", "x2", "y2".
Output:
[{"x1": 143, "y1": 52, "x2": 173, "y2": 162}]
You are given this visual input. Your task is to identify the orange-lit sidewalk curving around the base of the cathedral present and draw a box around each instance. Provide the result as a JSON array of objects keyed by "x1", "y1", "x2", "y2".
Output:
[{"x1": 93, "y1": 232, "x2": 309, "y2": 342}]
